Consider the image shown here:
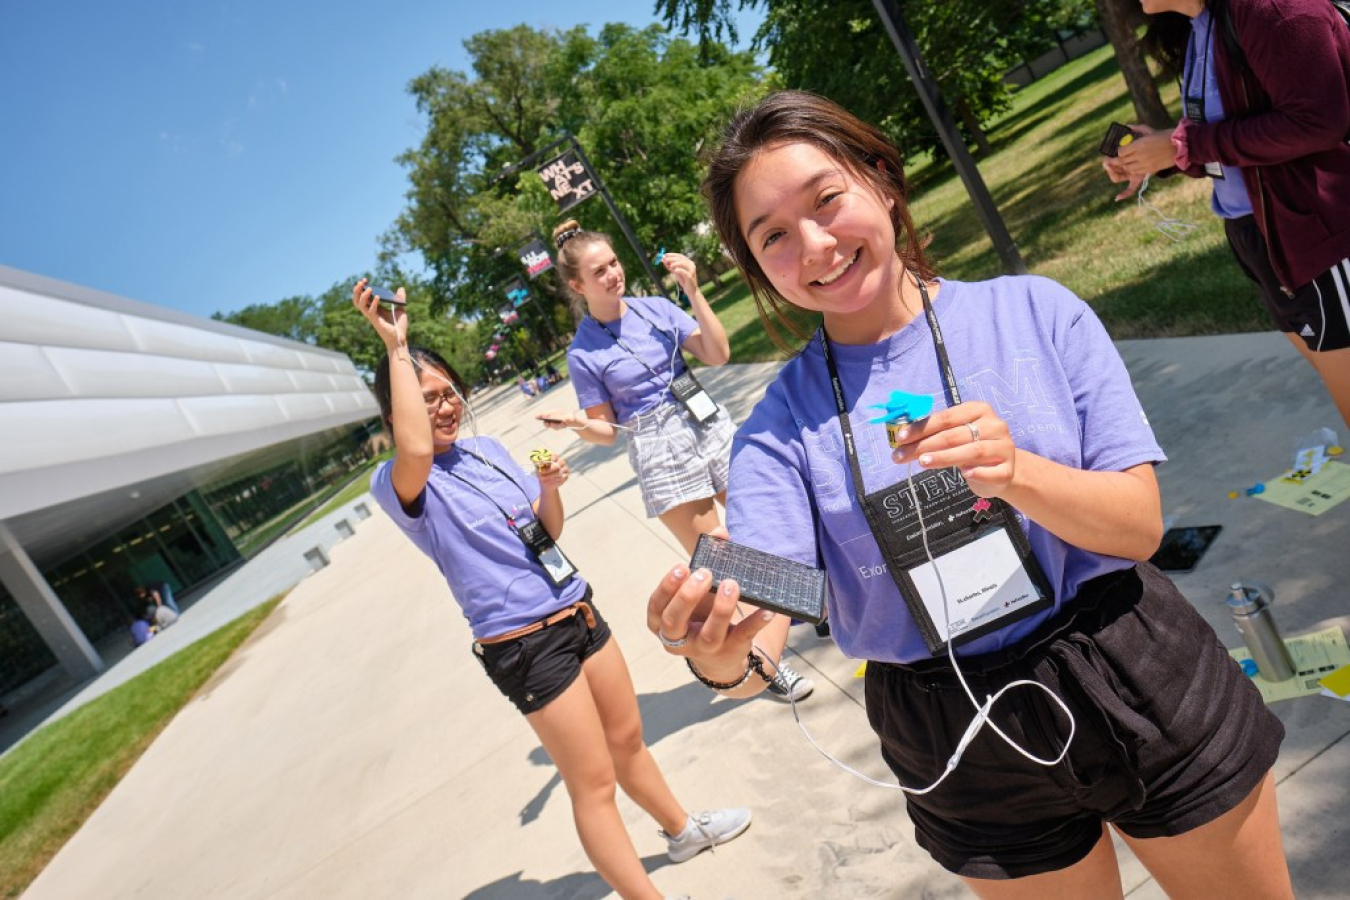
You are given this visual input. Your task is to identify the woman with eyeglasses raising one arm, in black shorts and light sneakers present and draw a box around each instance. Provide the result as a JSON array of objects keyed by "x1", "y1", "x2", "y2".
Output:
[{"x1": 352, "y1": 279, "x2": 751, "y2": 900}]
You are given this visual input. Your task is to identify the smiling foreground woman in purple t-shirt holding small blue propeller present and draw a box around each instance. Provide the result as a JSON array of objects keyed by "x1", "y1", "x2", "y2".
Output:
[{"x1": 648, "y1": 92, "x2": 1292, "y2": 900}]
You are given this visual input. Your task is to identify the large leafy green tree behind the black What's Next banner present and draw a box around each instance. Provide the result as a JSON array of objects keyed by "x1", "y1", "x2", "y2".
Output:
[{"x1": 385, "y1": 24, "x2": 763, "y2": 327}]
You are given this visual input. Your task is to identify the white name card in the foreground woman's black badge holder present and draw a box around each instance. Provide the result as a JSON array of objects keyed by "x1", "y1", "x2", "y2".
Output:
[{"x1": 909, "y1": 529, "x2": 1042, "y2": 644}]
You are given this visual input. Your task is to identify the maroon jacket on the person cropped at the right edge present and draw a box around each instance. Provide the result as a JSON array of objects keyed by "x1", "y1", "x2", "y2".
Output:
[{"x1": 1172, "y1": 0, "x2": 1350, "y2": 290}]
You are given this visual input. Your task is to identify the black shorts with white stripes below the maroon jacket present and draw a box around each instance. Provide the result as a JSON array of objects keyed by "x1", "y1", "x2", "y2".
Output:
[{"x1": 1223, "y1": 216, "x2": 1350, "y2": 352}]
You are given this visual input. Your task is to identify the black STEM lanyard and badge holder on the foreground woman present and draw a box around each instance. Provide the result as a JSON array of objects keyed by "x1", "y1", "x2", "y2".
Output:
[{"x1": 819, "y1": 279, "x2": 1053, "y2": 656}]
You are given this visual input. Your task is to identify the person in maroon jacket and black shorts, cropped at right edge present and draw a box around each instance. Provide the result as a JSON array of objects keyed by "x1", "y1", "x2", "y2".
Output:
[{"x1": 1106, "y1": 0, "x2": 1350, "y2": 424}]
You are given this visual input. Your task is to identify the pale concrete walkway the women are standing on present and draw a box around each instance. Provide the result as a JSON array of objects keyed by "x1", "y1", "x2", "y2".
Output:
[{"x1": 24, "y1": 333, "x2": 1350, "y2": 900}]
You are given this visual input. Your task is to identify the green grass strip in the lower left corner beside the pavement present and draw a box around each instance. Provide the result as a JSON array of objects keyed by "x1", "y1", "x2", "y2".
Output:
[{"x1": 0, "y1": 596, "x2": 281, "y2": 897}]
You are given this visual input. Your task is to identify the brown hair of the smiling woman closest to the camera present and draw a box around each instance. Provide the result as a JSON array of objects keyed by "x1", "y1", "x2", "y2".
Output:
[{"x1": 702, "y1": 90, "x2": 934, "y2": 349}]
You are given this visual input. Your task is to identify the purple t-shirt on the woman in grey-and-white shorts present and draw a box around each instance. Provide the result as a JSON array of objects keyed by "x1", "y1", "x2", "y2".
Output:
[{"x1": 567, "y1": 297, "x2": 698, "y2": 422}]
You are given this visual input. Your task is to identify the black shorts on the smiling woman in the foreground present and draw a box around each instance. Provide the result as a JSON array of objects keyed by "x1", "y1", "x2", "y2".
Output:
[{"x1": 867, "y1": 564, "x2": 1284, "y2": 878}]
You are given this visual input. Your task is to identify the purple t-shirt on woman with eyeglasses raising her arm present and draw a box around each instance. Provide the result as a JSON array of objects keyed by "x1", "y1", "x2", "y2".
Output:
[{"x1": 370, "y1": 437, "x2": 586, "y2": 637}]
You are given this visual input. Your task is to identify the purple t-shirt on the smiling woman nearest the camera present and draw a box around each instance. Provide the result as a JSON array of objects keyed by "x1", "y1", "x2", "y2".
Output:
[{"x1": 726, "y1": 277, "x2": 1166, "y2": 663}]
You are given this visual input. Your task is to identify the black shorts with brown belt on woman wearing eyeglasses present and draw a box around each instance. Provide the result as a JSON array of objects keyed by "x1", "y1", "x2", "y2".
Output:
[{"x1": 474, "y1": 587, "x2": 610, "y2": 715}]
